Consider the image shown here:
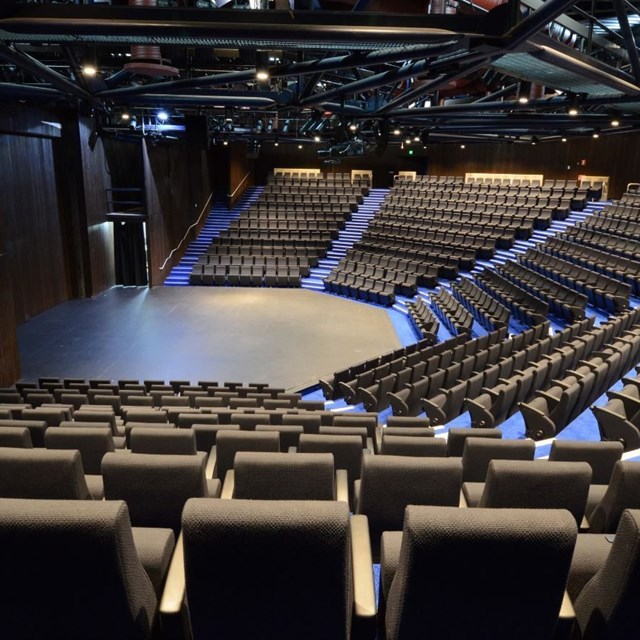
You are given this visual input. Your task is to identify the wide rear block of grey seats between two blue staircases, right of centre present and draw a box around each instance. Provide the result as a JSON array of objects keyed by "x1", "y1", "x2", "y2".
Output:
[{"x1": 325, "y1": 176, "x2": 586, "y2": 304}]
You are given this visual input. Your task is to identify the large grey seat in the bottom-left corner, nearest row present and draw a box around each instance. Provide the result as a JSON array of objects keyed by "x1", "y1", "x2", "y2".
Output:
[{"x1": 0, "y1": 499, "x2": 157, "y2": 640}]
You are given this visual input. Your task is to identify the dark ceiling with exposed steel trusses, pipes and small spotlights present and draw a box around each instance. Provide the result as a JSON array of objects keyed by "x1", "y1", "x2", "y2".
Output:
[{"x1": 0, "y1": 0, "x2": 640, "y2": 159}]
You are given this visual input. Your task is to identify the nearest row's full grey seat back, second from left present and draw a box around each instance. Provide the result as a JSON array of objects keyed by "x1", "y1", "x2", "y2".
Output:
[{"x1": 183, "y1": 500, "x2": 353, "y2": 640}]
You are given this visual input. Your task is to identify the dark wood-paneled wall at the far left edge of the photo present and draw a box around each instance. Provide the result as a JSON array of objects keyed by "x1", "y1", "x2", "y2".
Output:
[{"x1": 0, "y1": 135, "x2": 69, "y2": 324}]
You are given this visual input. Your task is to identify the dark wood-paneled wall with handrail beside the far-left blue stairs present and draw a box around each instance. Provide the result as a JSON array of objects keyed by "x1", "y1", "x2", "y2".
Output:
[{"x1": 142, "y1": 140, "x2": 211, "y2": 286}]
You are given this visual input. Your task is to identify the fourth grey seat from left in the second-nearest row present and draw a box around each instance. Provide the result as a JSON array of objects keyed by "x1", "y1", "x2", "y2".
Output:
[{"x1": 355, "y1": 456, "x2": 462, "y2": 558}]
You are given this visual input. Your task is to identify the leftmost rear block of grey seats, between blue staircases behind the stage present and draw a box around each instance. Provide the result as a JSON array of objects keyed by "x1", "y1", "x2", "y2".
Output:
[{"x1": 189, "y1": 174, "x2": 368, "y2": 287}]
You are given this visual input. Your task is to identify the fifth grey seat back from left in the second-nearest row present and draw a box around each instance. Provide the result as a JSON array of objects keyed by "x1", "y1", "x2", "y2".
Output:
[{"x1": 478, "y1": 460, "x2": 591, "y2": 526}]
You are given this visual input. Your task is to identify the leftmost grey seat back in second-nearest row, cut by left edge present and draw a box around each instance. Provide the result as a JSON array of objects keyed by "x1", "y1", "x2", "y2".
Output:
[{"x1": 0, "y1": 448, "x2": 91, "y2": 500}]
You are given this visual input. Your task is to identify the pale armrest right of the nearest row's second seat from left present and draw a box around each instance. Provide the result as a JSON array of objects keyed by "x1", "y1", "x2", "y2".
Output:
[{"x1": 349, "y1": 515, "x2": 376, "y2": 638}]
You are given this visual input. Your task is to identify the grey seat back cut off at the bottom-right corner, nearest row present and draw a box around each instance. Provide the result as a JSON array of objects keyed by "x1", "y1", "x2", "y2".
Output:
[{"x1": 574, "y1": 510, "x2": 640, "y2": 638}]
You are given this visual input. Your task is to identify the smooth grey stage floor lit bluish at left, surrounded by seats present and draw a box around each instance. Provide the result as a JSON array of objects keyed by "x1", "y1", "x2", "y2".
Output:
[{"x1": 18, "y1": 287, "x2": 400, "y2": 388}]
